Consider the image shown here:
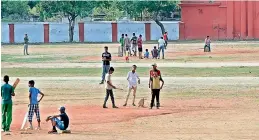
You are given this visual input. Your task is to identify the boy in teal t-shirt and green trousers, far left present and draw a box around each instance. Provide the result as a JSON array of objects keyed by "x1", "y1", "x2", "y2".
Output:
[{"x1": 1, "y1": 75, "x2": 15, "y2": 132}]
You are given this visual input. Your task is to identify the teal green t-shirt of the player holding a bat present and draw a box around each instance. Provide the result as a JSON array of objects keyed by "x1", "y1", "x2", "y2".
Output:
[{"x1": 1, "y1": 84, "x2": 14, "y2": 104}]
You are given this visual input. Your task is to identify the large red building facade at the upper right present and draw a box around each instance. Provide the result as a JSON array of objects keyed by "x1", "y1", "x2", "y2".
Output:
[{"x1": 180, "y1": 0, "x2": 259, "y2": 40}]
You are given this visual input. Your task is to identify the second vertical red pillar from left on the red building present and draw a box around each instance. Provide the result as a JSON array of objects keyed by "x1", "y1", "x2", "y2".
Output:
[{"x1": 240, "y1": 0, "x2": 247, "y2": 39}]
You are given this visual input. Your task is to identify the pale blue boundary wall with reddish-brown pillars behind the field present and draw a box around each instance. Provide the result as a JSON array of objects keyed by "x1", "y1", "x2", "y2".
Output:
[{"x1": 1, "y1": 22, "x2": 179, "y2": 43}]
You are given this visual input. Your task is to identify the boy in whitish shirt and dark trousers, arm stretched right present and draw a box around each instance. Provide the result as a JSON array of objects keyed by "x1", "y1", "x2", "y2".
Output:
[{"x1": 103, "y1": 67, "x2": 118, "y2": 108}]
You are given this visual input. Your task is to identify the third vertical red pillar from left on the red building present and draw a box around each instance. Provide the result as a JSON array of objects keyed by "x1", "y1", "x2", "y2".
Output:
[{"x1": 247, "y1": 1, "x2": 254, "y2": 39}]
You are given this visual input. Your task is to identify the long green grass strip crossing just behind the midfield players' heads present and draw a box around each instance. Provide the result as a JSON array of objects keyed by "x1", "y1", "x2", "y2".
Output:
[{"x1": 1, "y1": 67, "x2": 259, "y2": 77}]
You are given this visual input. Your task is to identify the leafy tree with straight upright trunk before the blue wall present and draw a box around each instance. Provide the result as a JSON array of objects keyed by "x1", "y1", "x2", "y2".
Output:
[{"x1": 39, "y1": 1, "x2": 96, "y2": 42}]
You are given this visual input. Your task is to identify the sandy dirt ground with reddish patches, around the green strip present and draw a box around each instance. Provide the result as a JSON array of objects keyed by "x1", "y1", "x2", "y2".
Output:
[{"x1": 2, "y1": 42, "x2": 259, "y2": 140}]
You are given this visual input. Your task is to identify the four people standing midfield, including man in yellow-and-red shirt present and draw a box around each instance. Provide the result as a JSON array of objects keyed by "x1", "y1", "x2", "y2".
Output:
[{"x1": 100, "y1": 46, "x2": 164, "y2": 109}]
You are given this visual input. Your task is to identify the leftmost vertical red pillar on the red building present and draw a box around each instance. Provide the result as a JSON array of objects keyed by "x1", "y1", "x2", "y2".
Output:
[{"x1": 227, "y1": 1, "x2": 234, "y2": 39}]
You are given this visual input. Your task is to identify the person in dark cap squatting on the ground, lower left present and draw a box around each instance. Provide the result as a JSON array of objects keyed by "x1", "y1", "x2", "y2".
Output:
[{"x1": 46, "y1": 106, "x2": 69, "y2": 133}]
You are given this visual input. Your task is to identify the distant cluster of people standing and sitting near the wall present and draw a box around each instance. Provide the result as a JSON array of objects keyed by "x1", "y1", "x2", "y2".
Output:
[{"x1": 118, "y1": 32, "x2": 171, "y2": 62}]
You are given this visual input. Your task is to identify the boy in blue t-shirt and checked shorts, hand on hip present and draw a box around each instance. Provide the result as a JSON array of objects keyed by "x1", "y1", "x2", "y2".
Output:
[{"x1": 28, "y1": 80, "x2": 44, "y2": 130}]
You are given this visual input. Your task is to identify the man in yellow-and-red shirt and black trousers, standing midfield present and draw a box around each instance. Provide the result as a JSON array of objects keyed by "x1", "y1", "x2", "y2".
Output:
[{"x1": 150, "y1": 70, "x2": 164, "y2": 109}]
